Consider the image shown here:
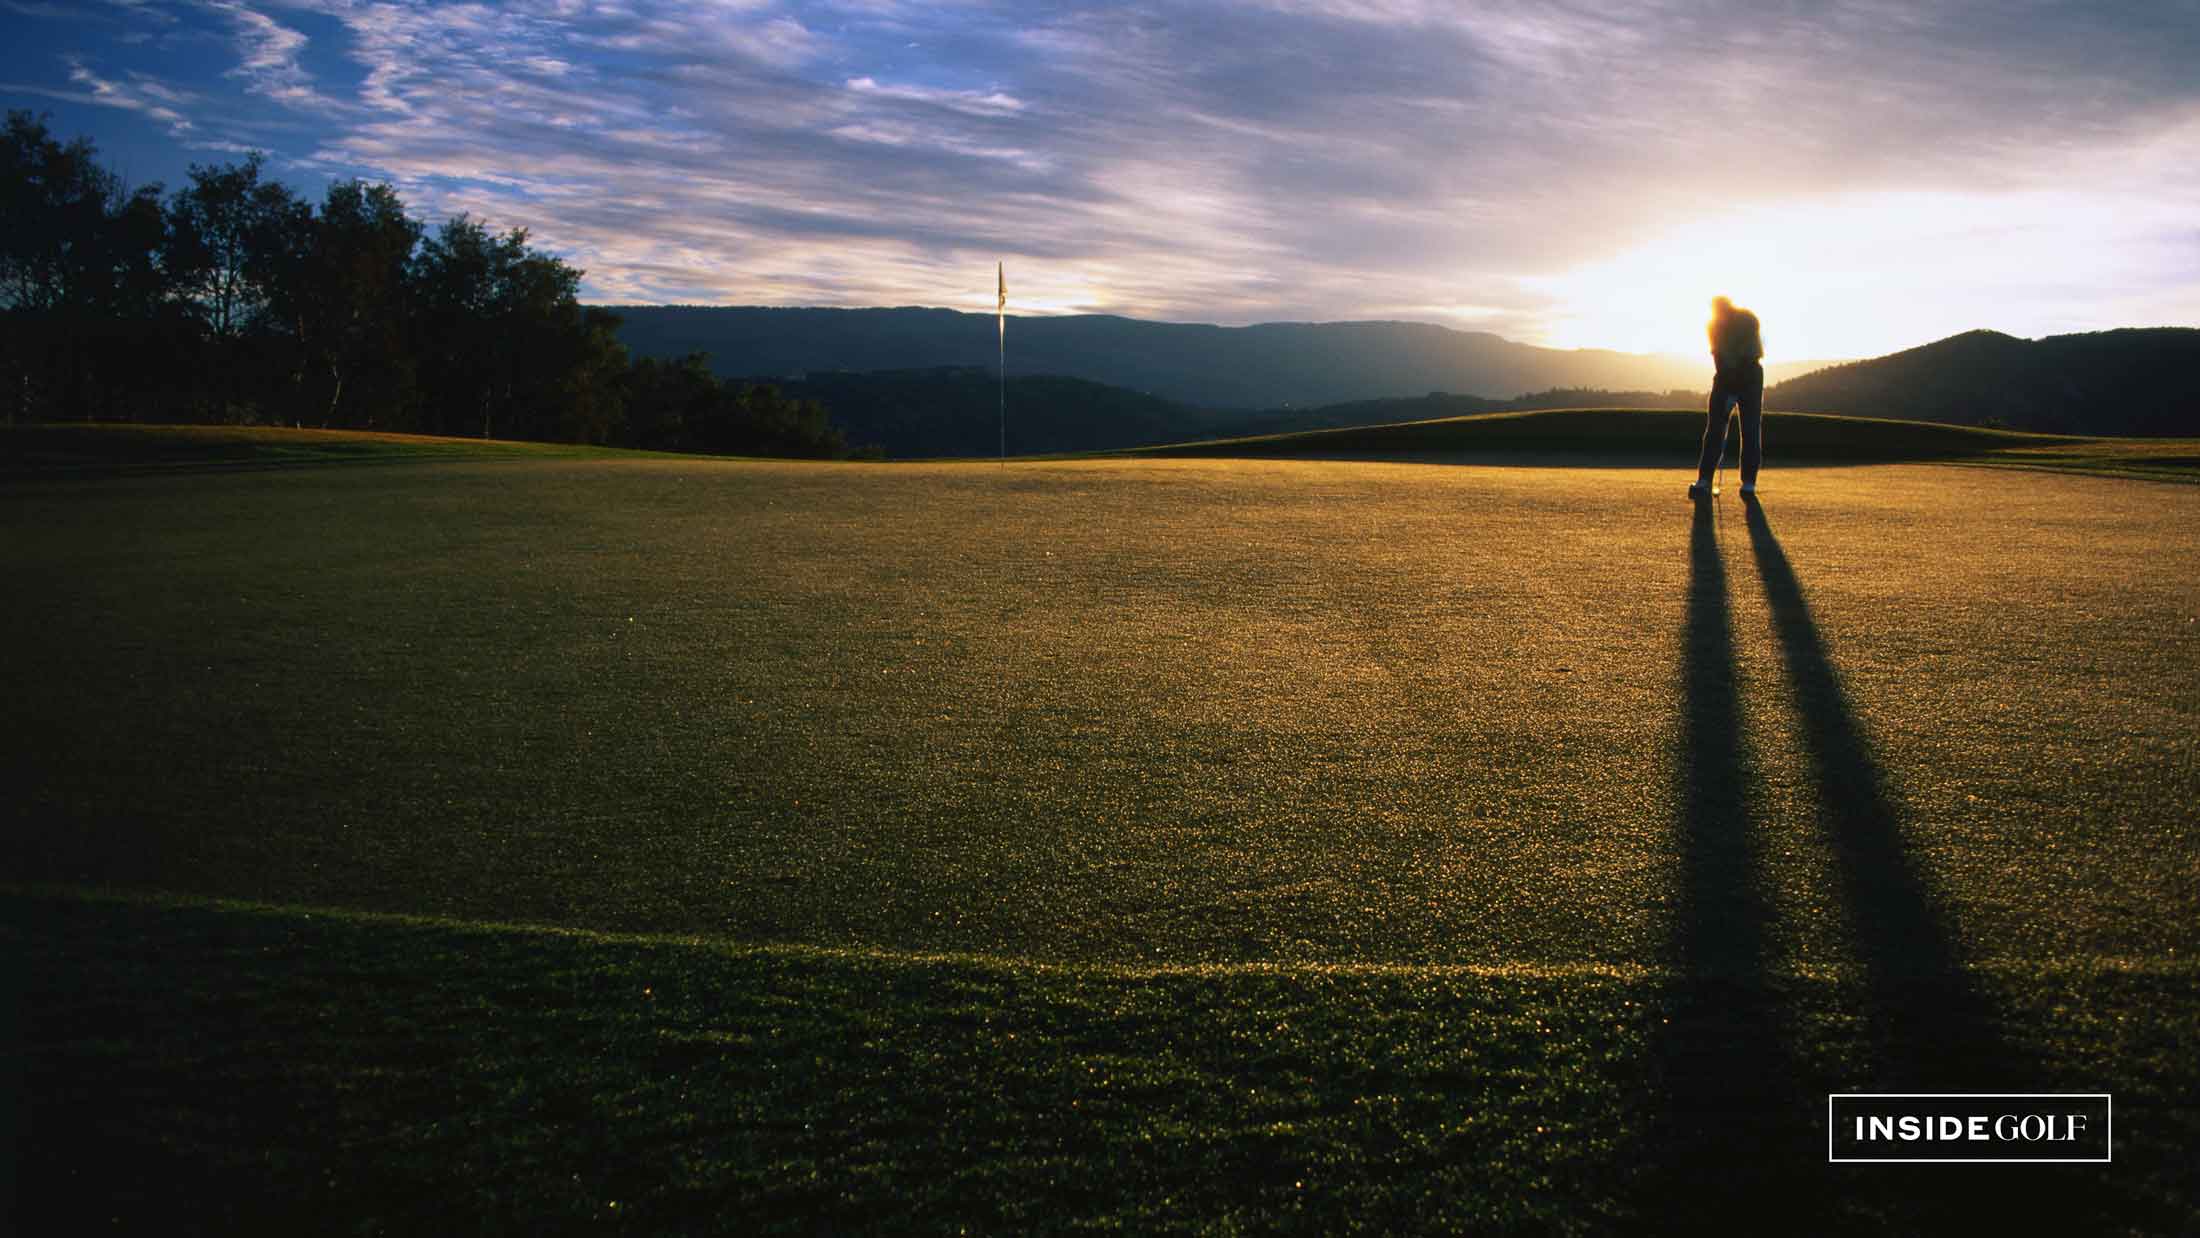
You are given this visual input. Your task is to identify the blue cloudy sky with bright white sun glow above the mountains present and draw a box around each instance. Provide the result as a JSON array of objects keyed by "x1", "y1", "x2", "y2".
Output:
[{"x1": 0, "y1": 0, "x2": 2200, "y2": 361}]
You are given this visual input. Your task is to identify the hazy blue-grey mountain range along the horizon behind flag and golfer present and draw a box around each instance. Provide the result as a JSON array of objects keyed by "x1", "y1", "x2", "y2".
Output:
[{"x1": 616, "y1": 306, "x2": 2200, "y2": 457}]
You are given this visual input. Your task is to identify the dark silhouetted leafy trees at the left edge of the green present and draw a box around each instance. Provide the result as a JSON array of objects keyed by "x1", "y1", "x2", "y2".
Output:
[{"x1": 0, "y1": 112, "x2": 847, "y2": 457}]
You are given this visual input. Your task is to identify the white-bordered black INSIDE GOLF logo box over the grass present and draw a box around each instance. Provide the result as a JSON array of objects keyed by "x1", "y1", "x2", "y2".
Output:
[{"x1": 1826, "y1": 1093, "x2": 2112, "y2": 1161}]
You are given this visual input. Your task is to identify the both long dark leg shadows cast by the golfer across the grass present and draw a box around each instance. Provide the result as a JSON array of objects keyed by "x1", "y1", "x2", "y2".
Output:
[{"x1": 1641, "y1": 501, "x2": 2112, "y2": 1231}]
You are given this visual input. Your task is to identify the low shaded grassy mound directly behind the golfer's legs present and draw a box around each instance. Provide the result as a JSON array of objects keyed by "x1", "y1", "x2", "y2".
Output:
[{"x1": 1133, "y1": 409, "x2": 2200, "y2": 482}]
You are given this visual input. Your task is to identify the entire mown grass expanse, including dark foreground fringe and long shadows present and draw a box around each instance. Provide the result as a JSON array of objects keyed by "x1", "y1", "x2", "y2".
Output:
[{"x1": 0, "y1": 428, "x2": 2200, "y2": 1231}]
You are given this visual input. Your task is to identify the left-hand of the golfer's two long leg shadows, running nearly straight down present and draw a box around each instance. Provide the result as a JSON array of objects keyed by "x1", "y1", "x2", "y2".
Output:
[{"x1": 1637, "y1": 504, "x2": 1822, "y2": 1234}]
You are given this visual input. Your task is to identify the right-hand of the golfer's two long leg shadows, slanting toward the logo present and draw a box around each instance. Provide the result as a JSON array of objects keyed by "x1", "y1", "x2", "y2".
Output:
[{"x1": 1745, "y1": 501, "x2": 2116, "y2": 1234}]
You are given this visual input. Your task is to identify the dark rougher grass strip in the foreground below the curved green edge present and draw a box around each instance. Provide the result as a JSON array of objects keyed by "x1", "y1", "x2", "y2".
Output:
[{"x1": 0, "y1": 891, "x2": 2200, "y2": 1234}]
